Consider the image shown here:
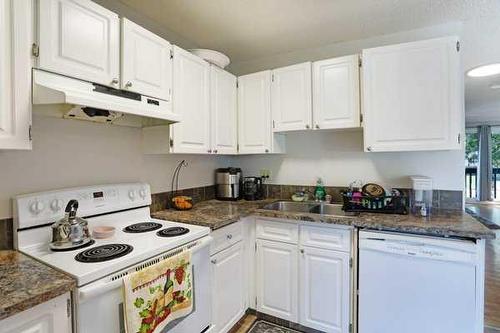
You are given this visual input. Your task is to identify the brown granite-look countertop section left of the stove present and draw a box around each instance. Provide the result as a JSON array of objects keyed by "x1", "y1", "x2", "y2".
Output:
[{"x1": 0, "y1": 250, "x2": 76, "y2": 320}]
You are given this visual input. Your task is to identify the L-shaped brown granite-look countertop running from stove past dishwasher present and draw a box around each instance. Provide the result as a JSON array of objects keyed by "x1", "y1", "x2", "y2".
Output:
[{"x1": 152, "y1": 199, "x2": 495, "y2": 239}]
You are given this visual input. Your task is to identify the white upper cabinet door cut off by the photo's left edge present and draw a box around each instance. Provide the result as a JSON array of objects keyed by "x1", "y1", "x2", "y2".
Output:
[{"x1": 0, "y1": 0, "x2": 32, "y2": 149}]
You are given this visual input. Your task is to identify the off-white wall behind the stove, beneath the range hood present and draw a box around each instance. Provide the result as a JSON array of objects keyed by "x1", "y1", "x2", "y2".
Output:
[{"x1": 0, "y1": 115, "x2": 226, "y2": 219}]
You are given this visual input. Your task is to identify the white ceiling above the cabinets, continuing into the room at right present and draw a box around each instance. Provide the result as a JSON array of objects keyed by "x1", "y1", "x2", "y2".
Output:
[{"x1": 102, "y1": 0, "x2": 500, "y2": 124}]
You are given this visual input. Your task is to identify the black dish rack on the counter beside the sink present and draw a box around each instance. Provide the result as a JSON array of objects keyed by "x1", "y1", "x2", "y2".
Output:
[{"x1": 342, "y1": 192, "x2": 408, "y2": 215}]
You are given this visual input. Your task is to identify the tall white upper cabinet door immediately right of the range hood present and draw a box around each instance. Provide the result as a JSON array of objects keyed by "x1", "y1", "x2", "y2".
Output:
[{"x1": 171, "y1": 46, "x2": 211, "y2": 154}]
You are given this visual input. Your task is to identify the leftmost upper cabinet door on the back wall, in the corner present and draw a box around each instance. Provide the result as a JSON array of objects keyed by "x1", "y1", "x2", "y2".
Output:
[{"x1": 238, "y1": 71, "x2": 272, "y2": 154}]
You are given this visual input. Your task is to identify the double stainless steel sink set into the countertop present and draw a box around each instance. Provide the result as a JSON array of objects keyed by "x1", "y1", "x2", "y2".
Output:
[{"x1": 262, "y1": 201, "x2": 358, "y2": 217}]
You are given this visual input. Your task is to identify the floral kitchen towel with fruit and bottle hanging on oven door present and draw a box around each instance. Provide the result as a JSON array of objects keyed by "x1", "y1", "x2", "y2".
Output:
[{"x1": 123, "y1": 250, "x2": 193, "y2": 333}]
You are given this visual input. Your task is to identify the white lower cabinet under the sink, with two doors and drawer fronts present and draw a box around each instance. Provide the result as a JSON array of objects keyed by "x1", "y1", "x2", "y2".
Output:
[{"x1": 255, "y1": 218, "x2": 352, "y2": 333}]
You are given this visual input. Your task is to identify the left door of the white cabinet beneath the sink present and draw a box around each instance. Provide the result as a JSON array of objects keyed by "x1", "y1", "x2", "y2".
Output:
[{"x1": 256, "y1": 239, "x2": 298, "y2": 322}]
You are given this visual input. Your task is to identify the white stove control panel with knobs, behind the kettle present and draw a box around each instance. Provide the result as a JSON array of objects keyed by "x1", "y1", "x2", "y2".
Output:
[{"x1": 14, "y1": 183, "x2": 151, "y2": 229}]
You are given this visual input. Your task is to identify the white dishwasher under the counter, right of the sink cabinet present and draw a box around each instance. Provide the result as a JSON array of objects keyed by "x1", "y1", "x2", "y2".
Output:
[{"x1": 358, "y1": 231, "x2": 484, "y2": 333}]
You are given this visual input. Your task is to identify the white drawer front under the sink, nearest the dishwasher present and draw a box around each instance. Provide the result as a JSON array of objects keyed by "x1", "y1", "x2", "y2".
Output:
[{"x1": 300, "y1": 225, "x2": 351, "y2": 252}]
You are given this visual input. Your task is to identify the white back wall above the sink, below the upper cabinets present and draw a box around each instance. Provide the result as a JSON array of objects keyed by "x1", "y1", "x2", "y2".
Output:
[{"x1": 231, "y1": 131, "x2": 464, "y2": 190}]
